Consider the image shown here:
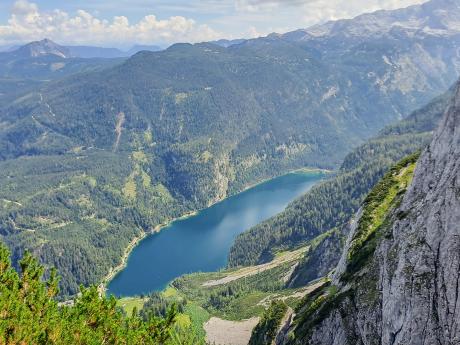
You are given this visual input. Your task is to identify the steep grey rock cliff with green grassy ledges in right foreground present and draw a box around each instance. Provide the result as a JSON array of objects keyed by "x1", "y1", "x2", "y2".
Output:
[{"x1": 290, "y1": 85, "x2": 460, "y2": 345}]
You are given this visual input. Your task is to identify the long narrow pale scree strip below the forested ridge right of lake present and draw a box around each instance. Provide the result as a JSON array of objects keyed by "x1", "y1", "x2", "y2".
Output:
[{"x1": 202, "y1": 247, "x2": 308, "y2": 287}]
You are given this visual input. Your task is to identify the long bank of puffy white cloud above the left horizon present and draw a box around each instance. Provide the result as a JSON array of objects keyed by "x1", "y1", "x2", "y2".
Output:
[{"x1": 0, "y1": 0, "x2": 221, "y2": 46}]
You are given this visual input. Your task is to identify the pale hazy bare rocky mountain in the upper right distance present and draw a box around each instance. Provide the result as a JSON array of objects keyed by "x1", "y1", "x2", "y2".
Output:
[{"x1": 281, "y1": 0, "x2": 460, "y2": 114}]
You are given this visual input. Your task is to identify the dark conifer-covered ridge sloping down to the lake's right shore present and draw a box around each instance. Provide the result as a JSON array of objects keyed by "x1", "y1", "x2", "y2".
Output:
[{"x1": 229, "y1": 91, "x2": 452, "y2": 272}]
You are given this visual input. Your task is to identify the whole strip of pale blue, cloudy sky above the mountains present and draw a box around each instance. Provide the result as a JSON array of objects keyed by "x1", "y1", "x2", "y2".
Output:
[{"x1": 0, "y1": 0, "x2": 426, "y2": 47}]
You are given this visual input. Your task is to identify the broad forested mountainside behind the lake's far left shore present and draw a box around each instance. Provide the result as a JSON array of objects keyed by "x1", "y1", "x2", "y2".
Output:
[{"x1": 0, "y1": 1, "x2": 460, "y2": 294}]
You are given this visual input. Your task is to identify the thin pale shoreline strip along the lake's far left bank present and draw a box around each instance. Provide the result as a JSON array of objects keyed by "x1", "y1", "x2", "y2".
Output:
[{"x1": 98, "y1": 168, "x2": 332, "y2": 294}]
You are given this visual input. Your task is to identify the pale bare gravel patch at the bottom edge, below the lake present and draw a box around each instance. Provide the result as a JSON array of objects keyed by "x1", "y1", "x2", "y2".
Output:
[{"x1": 203, "y1": 317, "x2": 260, "y2": 345}]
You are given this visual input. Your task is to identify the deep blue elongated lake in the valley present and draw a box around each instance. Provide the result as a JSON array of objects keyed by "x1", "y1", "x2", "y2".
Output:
[{"x1": 108, "y1": 173, "x2": 324, "y2": 296}]
